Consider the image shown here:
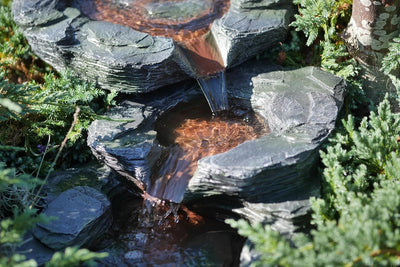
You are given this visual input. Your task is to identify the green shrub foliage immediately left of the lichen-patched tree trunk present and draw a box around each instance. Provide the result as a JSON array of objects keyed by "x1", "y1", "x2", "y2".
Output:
[{"x1": 291, "y1": 0, "x2": 371, "y2": 114}]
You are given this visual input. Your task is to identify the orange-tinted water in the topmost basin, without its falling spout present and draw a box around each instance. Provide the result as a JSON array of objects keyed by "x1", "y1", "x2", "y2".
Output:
[{"x1": 73, "y1": 0, "x2": 229, "y2": 41}]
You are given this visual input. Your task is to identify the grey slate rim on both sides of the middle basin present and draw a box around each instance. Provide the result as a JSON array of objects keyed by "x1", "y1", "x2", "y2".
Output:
[{"x1": 88, "y1": 61, "x2": 345, "y2": 232}]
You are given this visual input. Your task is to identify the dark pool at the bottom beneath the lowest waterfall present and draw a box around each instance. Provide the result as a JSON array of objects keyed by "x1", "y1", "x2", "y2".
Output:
[{"x1": 97, "y1": 189, "x2": 244, "y2": 266}]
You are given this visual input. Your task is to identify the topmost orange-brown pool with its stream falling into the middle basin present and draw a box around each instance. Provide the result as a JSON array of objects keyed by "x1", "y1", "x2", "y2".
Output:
[{"x1": 73, "y1": 0, "x2": 229, "y2": 114}]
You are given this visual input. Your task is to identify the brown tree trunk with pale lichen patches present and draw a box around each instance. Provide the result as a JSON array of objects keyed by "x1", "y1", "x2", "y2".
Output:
[{"x1": 344, "y1": 0, "x2": 400, "y2": 103}]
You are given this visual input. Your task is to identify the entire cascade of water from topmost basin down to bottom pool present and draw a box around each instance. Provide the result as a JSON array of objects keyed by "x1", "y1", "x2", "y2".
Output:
[{"x1": 72, "y1": 0, "x2": 267, "y2": 266}]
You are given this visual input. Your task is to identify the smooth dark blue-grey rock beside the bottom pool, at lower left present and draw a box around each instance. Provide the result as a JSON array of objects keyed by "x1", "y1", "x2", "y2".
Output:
[{"x1": 33, "y1": 186, "x2": 112, "y2": 250}]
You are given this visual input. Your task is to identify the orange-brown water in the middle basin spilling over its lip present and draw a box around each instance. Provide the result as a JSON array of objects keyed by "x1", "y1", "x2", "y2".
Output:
[{"x1": 147, "y1": 101, "x2": 268, "y2": 202}]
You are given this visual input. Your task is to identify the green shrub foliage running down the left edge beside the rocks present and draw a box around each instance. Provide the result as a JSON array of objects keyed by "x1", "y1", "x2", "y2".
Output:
[{"x1": 0, "y1": 1, "x2": 111, "y2": 267}]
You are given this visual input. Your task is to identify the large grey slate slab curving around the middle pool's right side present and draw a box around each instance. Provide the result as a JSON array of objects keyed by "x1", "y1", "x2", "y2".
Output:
[{"x1": 184, "y1": 62, "x2": 346, "y2": 206}]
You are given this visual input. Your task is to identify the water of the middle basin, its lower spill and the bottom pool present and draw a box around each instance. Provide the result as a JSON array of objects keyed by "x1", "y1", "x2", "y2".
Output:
[{"x1": 94, "y1": 98, "x2": 267, "y2": 266}]
